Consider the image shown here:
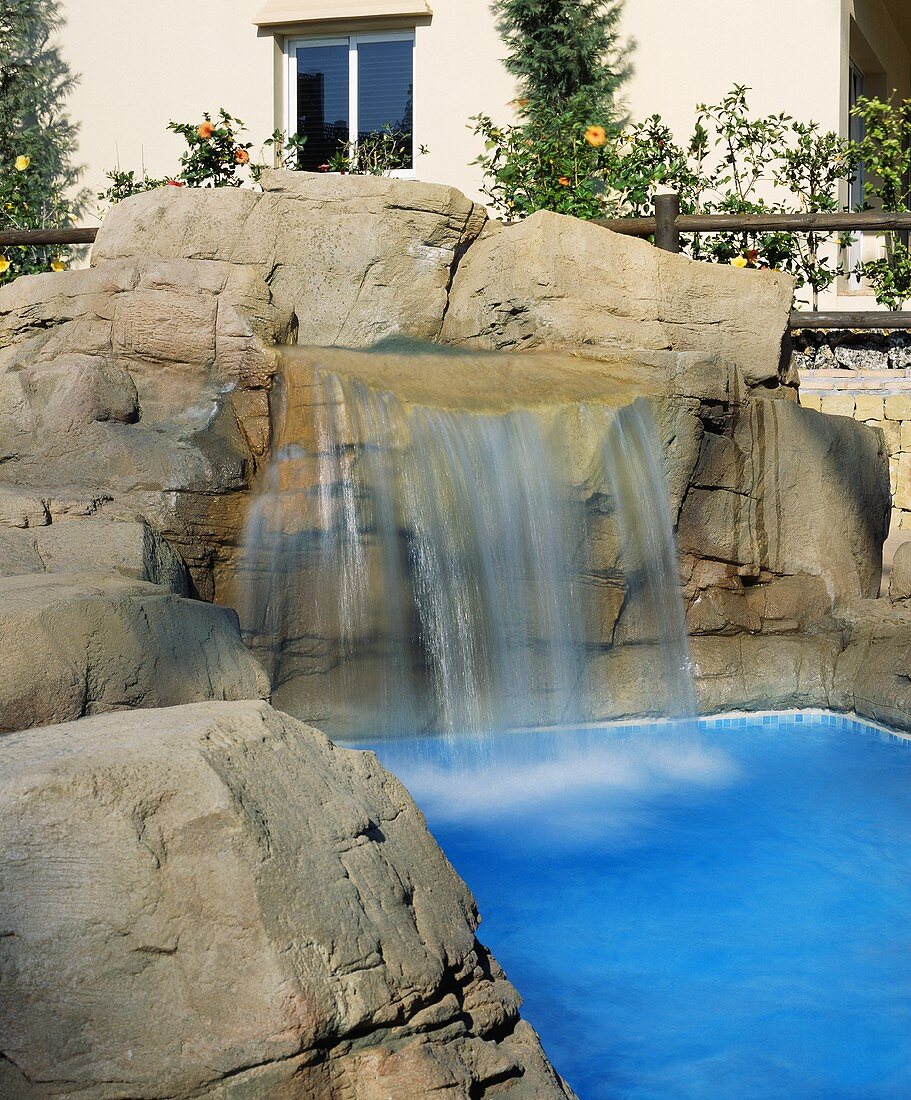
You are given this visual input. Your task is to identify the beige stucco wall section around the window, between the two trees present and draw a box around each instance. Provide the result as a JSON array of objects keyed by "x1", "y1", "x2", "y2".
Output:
[{"x1": 55, "y1": 0, "x2": 515, "y2": 213}]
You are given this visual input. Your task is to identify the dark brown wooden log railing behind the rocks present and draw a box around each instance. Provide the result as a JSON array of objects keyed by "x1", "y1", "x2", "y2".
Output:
[{"x1": 0, "y1": 206, "x2": 911, "y2": 330}]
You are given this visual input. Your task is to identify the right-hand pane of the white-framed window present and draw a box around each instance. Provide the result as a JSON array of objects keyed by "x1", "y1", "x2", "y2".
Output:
[{"x1": 358, "y1": 41, "x2": 414, "y2": 168}]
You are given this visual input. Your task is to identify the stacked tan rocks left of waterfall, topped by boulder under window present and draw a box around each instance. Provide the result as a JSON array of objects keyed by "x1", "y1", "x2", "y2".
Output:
[{"x1": 0, "y1": 173, "x2": 486, "y2": 600}]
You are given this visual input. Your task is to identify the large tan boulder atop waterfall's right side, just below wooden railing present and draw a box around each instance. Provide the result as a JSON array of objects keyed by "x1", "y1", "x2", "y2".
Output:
[{"x1": 441, "y1": 211, "x2": 793, "y2": 388}]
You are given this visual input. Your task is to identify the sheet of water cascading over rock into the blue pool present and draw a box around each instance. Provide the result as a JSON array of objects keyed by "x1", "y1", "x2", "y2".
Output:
[{"x1": 241, "y1": 372, "x2": 693, "y2": 737}]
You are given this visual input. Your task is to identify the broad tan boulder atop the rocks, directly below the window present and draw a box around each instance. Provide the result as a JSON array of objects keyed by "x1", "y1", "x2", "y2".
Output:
[{"x1": 92, "y1": 172, "x2": 486, "y2": 348}]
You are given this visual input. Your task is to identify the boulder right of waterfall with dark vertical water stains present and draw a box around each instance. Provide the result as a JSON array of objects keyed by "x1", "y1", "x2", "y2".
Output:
[{"x1": 679, "y1": 399, "x2": 889, "y2": 602}]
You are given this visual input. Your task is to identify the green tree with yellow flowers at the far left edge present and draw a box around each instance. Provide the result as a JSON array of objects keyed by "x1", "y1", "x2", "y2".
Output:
[{"x1": 0, "y1": 0, "x2": 85, "y2": 283}]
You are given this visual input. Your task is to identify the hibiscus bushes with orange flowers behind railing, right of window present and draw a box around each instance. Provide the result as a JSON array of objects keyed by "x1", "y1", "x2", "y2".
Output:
[{"x1": 472, "y1": 85, "x2": 858, "y2": 304}]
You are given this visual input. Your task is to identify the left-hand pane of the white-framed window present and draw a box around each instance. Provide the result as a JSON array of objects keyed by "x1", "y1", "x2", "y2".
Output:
[{"x1": 297, "y1": 45, "x2": 349, "y2": 172}]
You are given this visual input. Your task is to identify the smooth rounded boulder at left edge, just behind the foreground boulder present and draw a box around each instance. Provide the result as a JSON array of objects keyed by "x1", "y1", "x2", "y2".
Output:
[{"x1": 0, "y1": 573, "x2": 270, "y2": 733}]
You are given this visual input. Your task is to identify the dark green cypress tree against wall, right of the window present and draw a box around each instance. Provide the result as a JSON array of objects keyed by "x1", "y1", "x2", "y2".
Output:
[{"x1": 494, "y1": 0, "x2": 630, "y2": 123}]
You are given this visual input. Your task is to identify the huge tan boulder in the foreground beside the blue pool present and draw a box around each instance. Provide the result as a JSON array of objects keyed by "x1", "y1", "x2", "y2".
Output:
[{"x1": 0, "y1": 703, "x2": 572, "y2": 1100}]
